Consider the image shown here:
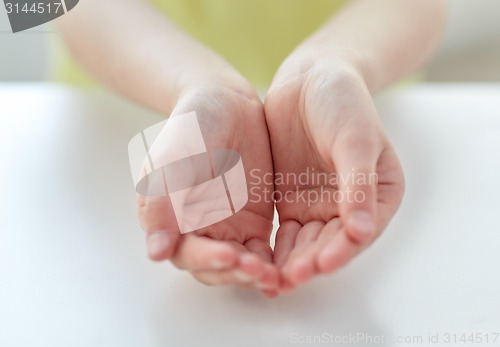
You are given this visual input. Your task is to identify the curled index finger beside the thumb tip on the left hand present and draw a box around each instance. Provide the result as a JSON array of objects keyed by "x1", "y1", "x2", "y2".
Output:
[{"x1": 171, "y1": 234, "x2": 239, "y2": 271}]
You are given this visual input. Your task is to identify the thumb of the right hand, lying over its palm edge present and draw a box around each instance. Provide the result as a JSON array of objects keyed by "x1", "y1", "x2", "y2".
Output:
[{"x1": 333, "y1": 130, "x2": 381, "y2": 243}]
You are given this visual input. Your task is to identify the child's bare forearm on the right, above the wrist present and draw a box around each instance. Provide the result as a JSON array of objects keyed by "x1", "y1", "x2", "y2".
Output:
[{"x1": 286, "y1": 0, "x2": 446, "y2": 92}]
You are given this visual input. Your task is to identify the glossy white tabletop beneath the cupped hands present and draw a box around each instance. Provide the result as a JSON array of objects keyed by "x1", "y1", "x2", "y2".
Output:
[{"x1": 0, "y1": 84, "x2": 500, "y2": 347}]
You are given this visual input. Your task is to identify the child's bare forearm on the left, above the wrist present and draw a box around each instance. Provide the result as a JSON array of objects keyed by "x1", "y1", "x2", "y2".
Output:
[{"x1": 60, "y1": 0, "x2": 249, "y2": 114}]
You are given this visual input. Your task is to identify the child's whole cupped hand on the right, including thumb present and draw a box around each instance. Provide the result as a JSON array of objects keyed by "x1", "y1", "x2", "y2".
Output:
[{"x1": 265, "y1": 61, "x2": 404, "y2": 290}]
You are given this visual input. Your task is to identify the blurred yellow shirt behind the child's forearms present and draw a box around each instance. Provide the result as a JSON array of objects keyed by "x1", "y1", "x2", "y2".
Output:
[{"x1": 55, "y1": 0, "x2": 345, "y2": 87}]
